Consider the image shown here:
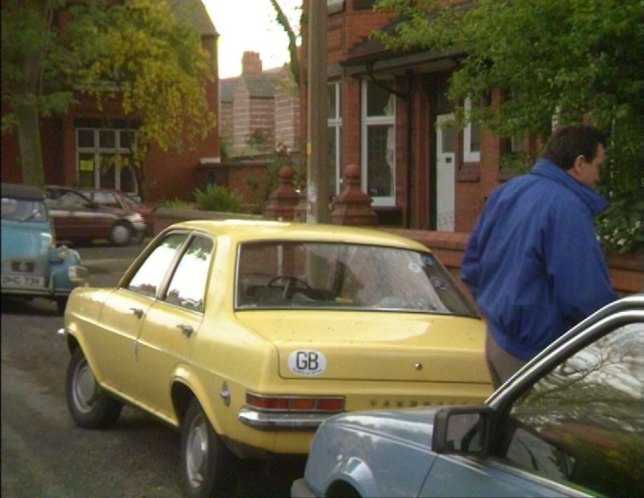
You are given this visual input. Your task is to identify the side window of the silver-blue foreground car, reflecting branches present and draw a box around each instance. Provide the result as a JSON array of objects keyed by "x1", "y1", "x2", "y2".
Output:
[{"x1": 503, "y1": 323, "x2": 644, "y2": 496}]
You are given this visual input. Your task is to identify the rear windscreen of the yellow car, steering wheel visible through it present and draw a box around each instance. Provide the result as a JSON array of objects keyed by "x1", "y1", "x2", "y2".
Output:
[{"x1": 236, "y1": 242, "x2": 475, "y2": 316}]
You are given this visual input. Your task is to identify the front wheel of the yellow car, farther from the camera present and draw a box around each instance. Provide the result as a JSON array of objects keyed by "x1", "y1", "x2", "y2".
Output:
[{"x1": 65, "y1": 348, "x2": 123, "y2": 429}]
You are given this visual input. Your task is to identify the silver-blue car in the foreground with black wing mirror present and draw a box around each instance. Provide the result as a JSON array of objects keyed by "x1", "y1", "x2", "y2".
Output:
[{"x1": 291, "y1": 294, "x2": 644, "y2": 498}]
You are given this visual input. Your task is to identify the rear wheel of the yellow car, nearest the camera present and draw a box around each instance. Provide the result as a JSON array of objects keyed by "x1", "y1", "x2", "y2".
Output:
[{"x1": 181, "y1": 399, "x2": 237, "y2": 497}]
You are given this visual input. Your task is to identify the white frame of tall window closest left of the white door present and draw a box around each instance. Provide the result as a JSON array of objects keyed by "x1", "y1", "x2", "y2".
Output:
[{"x1": 360, "y1": 78, "x2": 396, "y2": 207}]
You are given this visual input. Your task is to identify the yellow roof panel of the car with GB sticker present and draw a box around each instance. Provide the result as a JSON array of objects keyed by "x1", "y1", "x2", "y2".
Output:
[{"x1": 168, "y1": 219, "x2": 429, "y2": 251}]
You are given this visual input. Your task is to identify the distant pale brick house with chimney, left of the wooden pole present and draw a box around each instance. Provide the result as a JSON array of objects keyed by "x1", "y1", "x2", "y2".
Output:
[{"x1": 219, "y1": 51, "x2": 300, "y2": 158}]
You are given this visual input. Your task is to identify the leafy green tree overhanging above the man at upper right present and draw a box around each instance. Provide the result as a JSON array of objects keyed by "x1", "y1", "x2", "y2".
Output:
[{"x1": 376, "y1": 0, "x2": 644, "y2": 251}]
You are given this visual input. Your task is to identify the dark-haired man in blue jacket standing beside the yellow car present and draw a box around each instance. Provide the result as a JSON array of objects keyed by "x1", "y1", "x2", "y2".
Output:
[{"x1": 461, "y1": 125, "x2": 617, "y2": 388}]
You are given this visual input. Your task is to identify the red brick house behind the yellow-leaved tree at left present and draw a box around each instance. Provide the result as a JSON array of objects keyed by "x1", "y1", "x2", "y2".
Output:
[{"x1": 1, "y1": 0, "x2": 220, "y2": 202}]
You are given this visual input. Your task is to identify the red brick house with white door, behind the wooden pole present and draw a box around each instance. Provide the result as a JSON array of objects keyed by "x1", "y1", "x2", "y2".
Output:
[{"x1": 301, "y1": 0, "x2": 524, "y2": 232}]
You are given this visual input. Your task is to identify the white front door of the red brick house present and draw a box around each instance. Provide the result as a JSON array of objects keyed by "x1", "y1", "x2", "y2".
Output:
[{"x1": 435, "y1": 114, "x2": 456, "y2": 232}]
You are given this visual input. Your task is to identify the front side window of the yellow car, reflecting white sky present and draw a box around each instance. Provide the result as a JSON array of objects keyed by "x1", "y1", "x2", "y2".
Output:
[{"x1": 127, "y1": 234, "x2": 187, "y2": 297}]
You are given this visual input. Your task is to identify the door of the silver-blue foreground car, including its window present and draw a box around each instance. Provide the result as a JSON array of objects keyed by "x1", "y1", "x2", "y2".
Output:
[{"x1": 421, "y1": 320, "x2": 644, "y2": 496}]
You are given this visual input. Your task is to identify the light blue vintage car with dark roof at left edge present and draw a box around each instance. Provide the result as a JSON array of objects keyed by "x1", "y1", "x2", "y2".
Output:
[{"x1": 2, "y1": 183, "x2": 87, "y2": 313}]
